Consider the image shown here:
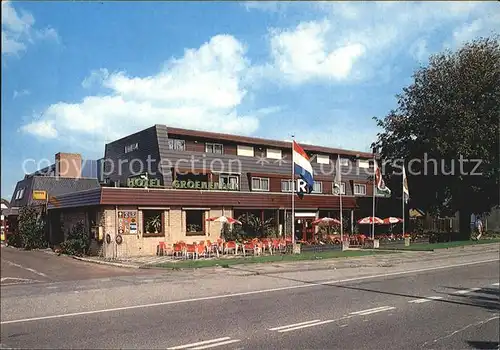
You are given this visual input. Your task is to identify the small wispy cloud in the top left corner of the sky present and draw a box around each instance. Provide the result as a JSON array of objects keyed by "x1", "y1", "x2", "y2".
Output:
[{"x1": 2, "y1": 1, "x2": 59, "y2": 55}]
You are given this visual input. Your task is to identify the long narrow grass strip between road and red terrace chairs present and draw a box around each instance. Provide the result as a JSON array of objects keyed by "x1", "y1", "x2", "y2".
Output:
[{"x1": 150, "y1": 250, "x2": 397, "y2": 269}]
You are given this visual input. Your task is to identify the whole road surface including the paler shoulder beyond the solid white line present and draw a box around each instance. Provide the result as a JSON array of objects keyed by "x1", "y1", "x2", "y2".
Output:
[{"x1": 1, "y1": 245, "x2": 500, "y2": 349}]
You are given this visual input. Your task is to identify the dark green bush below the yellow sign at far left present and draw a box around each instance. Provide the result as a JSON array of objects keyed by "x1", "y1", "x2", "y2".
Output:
[{"x1": 17, "y1": 206, "x2": 47, "y2": 250}]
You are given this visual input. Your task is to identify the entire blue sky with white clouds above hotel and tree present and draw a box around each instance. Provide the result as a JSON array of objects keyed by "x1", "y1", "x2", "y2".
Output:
[{"x1": 1, "y1": 1, "x2": 500, "y2": 198}]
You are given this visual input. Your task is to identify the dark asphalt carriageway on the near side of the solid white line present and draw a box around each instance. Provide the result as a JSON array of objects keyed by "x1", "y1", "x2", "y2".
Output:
[{"x1": 1, "y1": 261, "x2": 500, "y2": 349}]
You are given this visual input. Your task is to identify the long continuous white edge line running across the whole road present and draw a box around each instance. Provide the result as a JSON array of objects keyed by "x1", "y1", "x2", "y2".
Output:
[{"x1": 0, "y1": 259, "x2": 499, "y2": 324}]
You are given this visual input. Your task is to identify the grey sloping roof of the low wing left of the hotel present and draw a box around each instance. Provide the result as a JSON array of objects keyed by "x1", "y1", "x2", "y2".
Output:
[{"x1": 10, "y1": 176, "x2": 100, "y2": 207}]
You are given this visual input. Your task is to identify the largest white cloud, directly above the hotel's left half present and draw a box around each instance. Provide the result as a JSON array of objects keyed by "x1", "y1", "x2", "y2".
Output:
[{"x1": 23, "y1": 35, "x2": 259, "y2": 147}]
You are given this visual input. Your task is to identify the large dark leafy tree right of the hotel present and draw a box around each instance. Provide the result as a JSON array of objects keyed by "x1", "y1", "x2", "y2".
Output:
[{"x1": 373, "y1": 35, "x2": 500, "y2": 235}]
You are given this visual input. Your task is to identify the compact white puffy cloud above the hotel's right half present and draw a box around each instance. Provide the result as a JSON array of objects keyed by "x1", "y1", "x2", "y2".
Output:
[{"x1": 270, "y1": 20, "x2": 365, "y2": 83}]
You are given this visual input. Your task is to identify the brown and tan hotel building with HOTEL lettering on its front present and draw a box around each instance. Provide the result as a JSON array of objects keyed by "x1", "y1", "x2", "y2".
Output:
[{"x1": 44, "y1": 125, "x2": 386, "y2": 257}]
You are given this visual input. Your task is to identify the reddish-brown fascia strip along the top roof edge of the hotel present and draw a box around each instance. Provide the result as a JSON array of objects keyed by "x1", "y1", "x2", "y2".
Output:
[{"x1": 167, "y1": 126, "x2": 373, "y2": 158}]
